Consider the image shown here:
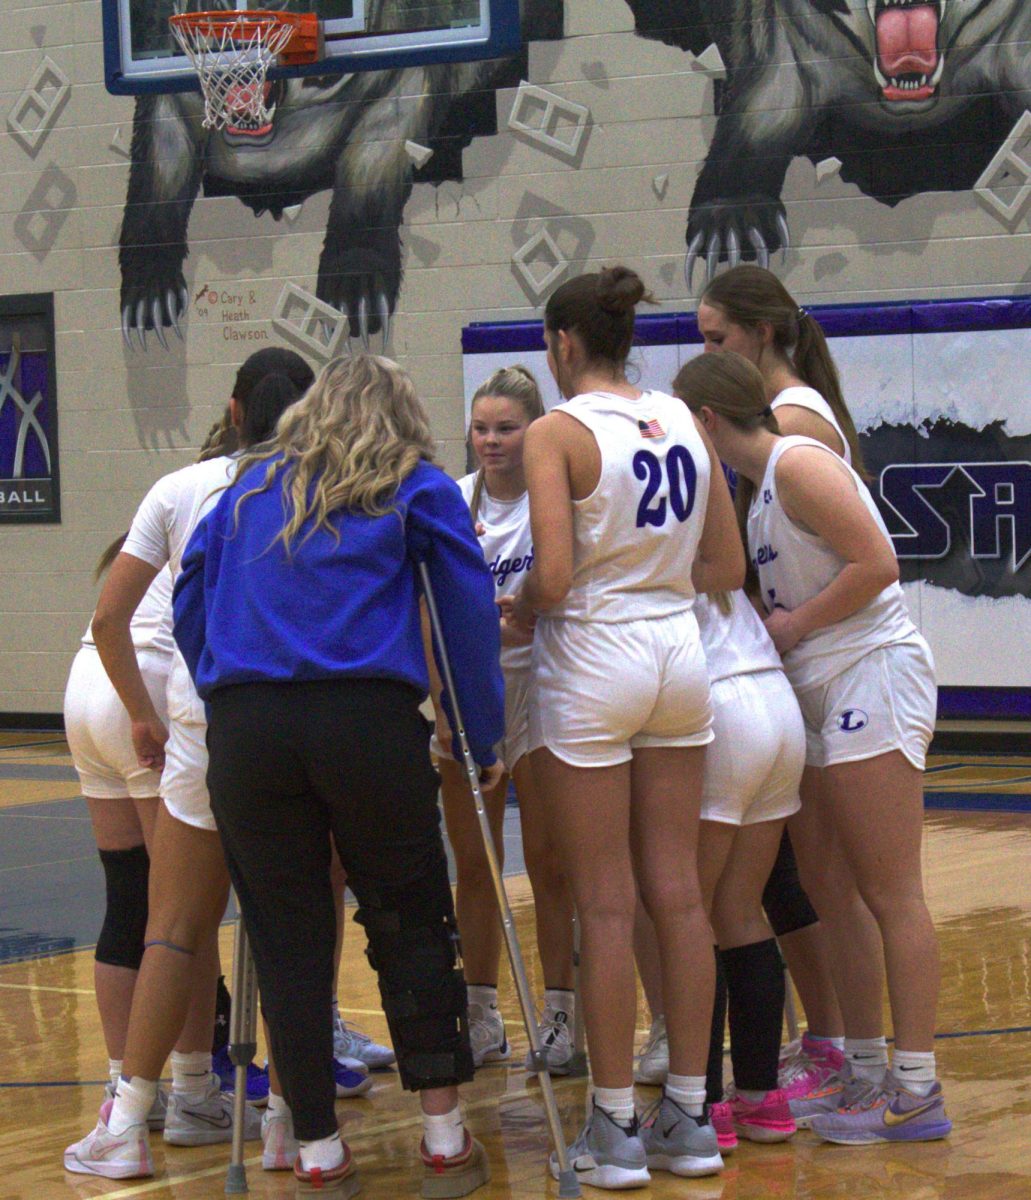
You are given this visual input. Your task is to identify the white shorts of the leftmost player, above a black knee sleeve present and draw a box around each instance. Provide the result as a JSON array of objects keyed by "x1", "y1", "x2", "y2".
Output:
[{"x1": 65, "y1": 646, "x2": 170, "y2": 800}]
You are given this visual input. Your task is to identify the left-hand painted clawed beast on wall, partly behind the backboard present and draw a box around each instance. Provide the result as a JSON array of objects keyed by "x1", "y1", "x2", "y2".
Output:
[{"x1": 119, "y1": 0, "x2": 563, "y2": 349}]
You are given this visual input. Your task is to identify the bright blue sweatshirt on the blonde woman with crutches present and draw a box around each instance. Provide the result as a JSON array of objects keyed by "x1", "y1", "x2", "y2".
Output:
[{"x1": 174, "y1": 453, "x2": 504, "y2": 767}]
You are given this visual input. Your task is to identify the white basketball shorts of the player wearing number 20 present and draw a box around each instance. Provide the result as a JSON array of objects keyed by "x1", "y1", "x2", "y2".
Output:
[{"x1": 529, "y1": 611, "x2": 713, "y2": 767}]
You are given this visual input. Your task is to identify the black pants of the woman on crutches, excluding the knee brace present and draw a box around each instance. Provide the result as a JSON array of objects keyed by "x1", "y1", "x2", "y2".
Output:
[{"x1": 205, "y1": 679, "x2": 470, "y2": 1141}]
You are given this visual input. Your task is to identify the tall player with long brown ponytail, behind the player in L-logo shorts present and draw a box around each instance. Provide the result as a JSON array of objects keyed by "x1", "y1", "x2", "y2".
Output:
[{"x1": 699, "y1": 264, "x2": 888, "y2": 1124}]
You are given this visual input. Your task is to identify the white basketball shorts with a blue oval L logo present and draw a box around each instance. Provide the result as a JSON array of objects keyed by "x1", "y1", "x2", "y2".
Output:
[{"x1": 798, "y1": 635, "x2": 937, "y2": 770}]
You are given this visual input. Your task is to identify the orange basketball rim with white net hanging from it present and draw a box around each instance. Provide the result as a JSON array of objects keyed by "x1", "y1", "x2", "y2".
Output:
[{"x1": 172, "y1": 13, "x2": 293, "y2": 130}]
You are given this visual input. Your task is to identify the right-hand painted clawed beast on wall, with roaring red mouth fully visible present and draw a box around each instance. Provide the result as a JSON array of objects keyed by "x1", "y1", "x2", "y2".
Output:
[{"x1": 628, "y1": 0, "x2": 1031, "y2": 287}]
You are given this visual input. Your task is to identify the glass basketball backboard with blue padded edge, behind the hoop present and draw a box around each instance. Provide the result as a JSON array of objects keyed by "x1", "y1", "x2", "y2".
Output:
[{"x1": 102, "y1": 0, "x2": 521, "y2": 95}]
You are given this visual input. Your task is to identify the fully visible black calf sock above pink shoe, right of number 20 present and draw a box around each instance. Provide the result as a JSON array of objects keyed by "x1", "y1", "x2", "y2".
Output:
[{"x1": 720, "y1": 937, "x2": 784, "y2": 1092}]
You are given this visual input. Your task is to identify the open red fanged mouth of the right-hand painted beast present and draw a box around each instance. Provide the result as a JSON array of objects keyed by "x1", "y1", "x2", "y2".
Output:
[{"x1": 867, "y1": 0, "x2": 946, "y2": 102}]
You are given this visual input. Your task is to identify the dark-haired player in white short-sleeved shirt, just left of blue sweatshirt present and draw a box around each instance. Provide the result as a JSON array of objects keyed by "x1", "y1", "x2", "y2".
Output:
[{"x1": 65, "y1": 348, "x2": 314, "y2": 1178}]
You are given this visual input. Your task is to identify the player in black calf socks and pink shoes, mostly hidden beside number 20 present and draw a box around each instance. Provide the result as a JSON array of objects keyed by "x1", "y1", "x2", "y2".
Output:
[{"x1": 635, "y1": 580, "x2": 805, "y2": 1154}]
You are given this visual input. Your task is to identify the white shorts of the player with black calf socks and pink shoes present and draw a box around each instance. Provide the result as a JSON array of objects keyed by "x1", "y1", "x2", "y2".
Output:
[{"x1": 702, "y1": 671, "x2": 805, "y2": 826}]
